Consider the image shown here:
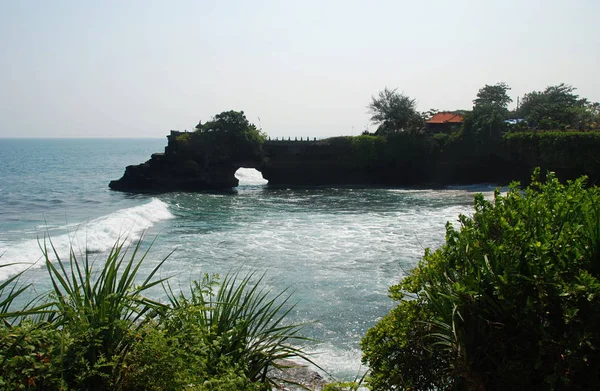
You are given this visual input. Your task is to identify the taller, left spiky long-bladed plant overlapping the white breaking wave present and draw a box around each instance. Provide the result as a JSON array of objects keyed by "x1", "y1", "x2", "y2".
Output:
[{"x1": 42, "y1": 241, "x2": 166, "y2": 390}]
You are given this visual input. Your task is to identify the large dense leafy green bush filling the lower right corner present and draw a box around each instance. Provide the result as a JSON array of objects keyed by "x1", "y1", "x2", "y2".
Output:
[{"x1": 362, "y1": 171, "x2": 600, "y2": 390}]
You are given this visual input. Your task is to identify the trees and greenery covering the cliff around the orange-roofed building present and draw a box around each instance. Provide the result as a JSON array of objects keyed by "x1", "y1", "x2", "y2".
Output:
[{"x1": 338, "y1": 83, "x2": 600, "y2": 185}]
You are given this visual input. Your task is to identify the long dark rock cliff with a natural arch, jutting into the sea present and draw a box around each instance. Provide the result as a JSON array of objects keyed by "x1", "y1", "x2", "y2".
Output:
[{"x1": 109, "y1": 131, "x2": 600, "y2": 192}]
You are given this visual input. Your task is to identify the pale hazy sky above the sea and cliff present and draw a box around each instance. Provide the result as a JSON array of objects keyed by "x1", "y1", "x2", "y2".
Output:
[{"x1": 0, "y1": 0, "x2": 600, "y2": 142}]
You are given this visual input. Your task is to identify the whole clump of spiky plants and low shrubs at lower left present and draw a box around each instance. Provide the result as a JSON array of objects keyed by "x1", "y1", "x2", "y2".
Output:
[{"x1": 0, "y1": 242, "x2": 310, "y2": 391}]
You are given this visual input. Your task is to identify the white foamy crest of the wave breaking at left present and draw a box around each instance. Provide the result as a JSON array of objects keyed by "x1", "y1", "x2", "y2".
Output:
[{"x1": 0, "y1": 198, "x2": 173, "y2": 281}]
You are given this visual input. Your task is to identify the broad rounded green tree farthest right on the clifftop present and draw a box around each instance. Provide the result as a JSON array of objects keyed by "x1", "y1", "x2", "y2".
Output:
[{"x1": 518, "y1": 83, "x2": 593, "y2": 130}]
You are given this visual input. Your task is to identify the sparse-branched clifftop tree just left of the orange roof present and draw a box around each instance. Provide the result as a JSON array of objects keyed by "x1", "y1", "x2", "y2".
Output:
[{"x1": 367, "y1": 87, "x2": 422, "y2": 135}]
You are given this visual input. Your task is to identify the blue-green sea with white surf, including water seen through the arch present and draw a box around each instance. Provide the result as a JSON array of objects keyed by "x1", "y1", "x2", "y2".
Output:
[{"x1": 0, "y1": 139, "x2": 494, "y2": 379}]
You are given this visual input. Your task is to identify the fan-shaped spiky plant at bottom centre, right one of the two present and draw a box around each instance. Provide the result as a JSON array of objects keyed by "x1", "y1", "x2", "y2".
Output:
[{"x1": 164, "y1": 273, "x2": 311, "y2": 385}]
